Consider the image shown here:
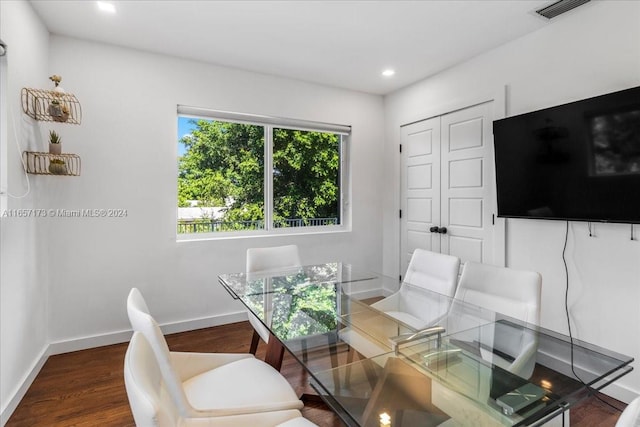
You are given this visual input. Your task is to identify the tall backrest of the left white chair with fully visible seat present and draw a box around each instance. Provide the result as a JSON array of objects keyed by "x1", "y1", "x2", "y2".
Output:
[{"x1": 127, "y1": 288, "x2": 193, "y2": 417}]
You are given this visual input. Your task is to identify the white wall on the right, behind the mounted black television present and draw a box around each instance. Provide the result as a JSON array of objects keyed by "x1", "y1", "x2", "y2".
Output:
[{"x1": 383, "y1": 1, "x2": 640, "y2": 400}]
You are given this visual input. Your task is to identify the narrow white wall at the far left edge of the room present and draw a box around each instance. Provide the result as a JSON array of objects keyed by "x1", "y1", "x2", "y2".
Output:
[{"x1": 0, "y1": 1, "x2": 50, "y2": 424}]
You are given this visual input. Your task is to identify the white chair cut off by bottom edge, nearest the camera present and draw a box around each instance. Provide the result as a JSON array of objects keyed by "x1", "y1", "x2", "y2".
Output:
[{"x1": 124, "y1": 332, "x2": 315, "y2": 427}]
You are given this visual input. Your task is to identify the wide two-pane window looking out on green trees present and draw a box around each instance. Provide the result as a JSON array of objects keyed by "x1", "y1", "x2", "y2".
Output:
[{"x1": 177, "y1": 107, "x2": 350, "y2": 235}]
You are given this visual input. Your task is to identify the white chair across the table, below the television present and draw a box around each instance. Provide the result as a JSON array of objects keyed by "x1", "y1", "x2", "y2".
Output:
[{"x1": 447, "y1": 261, "x2": 542, "y2": 378}]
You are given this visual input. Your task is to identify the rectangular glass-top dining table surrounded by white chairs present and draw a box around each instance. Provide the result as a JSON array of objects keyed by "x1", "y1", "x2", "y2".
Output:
[{"x1": 218, "y1": 262, "x2": 633, "y2": 427}]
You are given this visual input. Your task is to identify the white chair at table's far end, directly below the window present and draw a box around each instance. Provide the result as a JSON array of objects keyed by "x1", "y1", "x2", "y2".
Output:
[{"x1": 246, "y1": 245, "x2": 302, "y2": 354}]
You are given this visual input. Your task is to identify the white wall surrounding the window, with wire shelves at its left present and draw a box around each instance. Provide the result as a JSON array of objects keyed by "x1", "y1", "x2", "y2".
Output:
[{"x1": 42, "y1": 36, "x2": 384, "y2": 352}]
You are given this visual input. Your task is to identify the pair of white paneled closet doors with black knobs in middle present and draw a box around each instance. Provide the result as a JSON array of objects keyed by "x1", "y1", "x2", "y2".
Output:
[{"x1": 400, "y1": 102, "x2": 504, "y2": 272}]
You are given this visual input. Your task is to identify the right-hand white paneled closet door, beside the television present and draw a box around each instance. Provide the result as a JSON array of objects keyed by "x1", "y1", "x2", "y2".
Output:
[{"x1": 441, "y1": 102, "x2": 496, "y2": 264}]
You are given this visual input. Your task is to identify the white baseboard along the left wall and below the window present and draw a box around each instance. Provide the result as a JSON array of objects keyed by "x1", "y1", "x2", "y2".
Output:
[{"x1": 0, "y1": 311, "x2": 247, "y2": 426}]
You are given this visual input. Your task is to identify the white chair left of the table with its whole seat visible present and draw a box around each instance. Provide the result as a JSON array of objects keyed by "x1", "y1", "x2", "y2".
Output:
[{"x1": 127, "y1": 288, "x2": 303, "y2": 418}]
